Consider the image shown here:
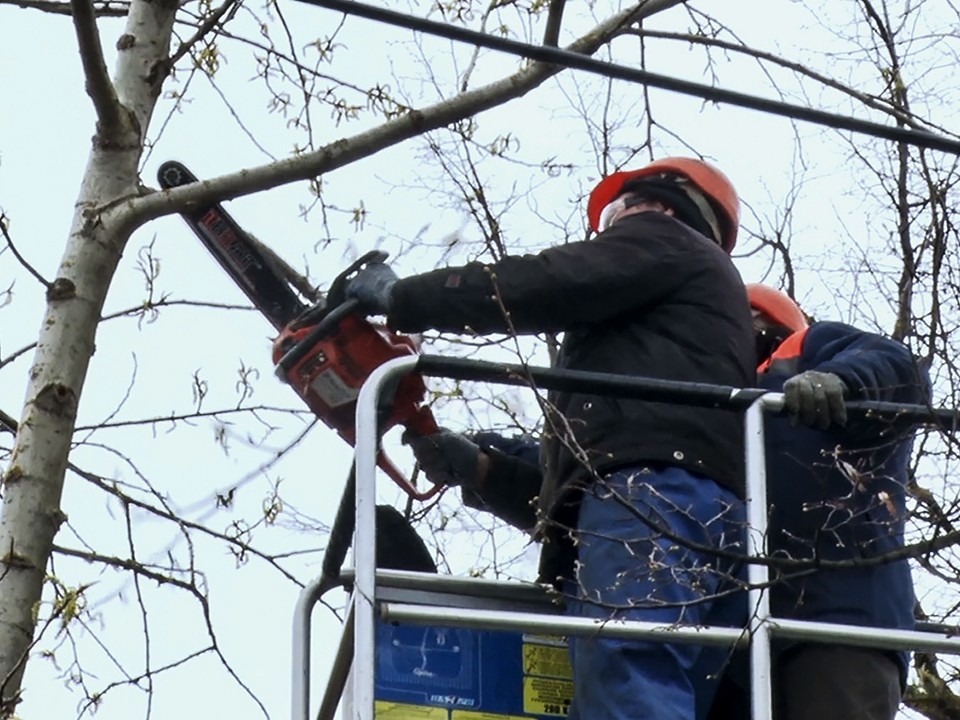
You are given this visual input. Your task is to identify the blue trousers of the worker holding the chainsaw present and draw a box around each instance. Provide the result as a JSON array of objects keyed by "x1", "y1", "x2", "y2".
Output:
[{"x1": 567, "y1": 467, "x2": 746, "y2": 720}]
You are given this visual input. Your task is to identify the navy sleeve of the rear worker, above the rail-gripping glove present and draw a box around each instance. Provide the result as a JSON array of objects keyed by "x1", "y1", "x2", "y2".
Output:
[{"x1": 801, "y1": 322, "x2": 930, "y2": 405}]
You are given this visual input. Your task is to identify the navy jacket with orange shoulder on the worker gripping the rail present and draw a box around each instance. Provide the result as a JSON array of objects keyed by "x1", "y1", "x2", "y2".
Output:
[{"x1": 759, "y1": 322, "x2": 930, "y2": 670}]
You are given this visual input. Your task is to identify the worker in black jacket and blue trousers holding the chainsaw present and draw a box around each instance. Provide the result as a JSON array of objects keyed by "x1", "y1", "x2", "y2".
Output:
[{"x1": 347, "y1": 158, "x2": 754, "y2": 720}]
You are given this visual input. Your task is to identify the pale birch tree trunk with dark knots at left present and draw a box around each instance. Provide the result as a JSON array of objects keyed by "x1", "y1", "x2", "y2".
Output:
[{"x1": 0, "y1": 0, "x2": 177, "y2": 718}]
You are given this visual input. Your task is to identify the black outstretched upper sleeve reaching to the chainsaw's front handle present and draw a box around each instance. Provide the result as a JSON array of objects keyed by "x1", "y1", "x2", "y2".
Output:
[{"x1": 387, "y1": 213, "x2": 723, "y2": 334}]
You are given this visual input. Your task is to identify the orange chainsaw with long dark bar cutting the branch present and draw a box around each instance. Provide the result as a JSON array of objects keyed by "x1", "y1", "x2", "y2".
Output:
[{"x1": 157, "y1": 161, "x2": 440, "y2": 500}]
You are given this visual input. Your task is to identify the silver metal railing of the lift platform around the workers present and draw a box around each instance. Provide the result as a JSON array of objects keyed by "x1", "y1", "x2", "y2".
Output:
[{"x1": 292, "y1": 355, "x2": 960, "y2": 720}]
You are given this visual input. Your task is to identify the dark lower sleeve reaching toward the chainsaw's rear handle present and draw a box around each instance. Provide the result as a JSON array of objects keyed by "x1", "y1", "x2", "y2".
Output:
[{"x1": 462, "y1": 433, "x2": 542, "y2": 531}]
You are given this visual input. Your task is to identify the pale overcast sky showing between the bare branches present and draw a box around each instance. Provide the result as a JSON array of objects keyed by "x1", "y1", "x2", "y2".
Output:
[{"x1": 0, "y1": 2, "x2": 948, "y2": 720}]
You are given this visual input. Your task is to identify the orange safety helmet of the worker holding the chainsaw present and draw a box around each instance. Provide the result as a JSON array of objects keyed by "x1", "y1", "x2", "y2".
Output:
[{"x1": 587, "y1": 157, "x2": 740, "y2": 253}]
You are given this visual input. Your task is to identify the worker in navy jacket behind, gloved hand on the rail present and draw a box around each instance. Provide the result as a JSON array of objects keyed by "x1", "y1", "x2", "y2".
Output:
[{"x1": 712, "y1": 285, "x2": 930, "y2": 720}]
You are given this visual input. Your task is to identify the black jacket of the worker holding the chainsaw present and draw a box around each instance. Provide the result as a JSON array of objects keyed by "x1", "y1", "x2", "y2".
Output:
[{"x1": 388, "y1": 213, "x2": 755, "y2": 580}]
